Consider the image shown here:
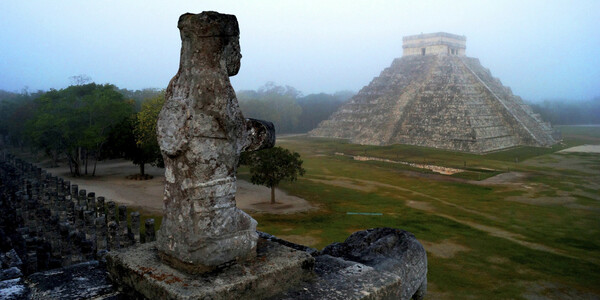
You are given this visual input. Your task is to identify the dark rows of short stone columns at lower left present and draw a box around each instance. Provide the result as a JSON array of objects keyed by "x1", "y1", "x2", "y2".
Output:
[{"x1": 0, "y1": 152, "x2": 155, "y2": 274}]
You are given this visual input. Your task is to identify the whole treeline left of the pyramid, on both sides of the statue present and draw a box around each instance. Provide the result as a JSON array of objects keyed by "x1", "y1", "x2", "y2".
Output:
[{"x1": 0, "y1": 80, "x2": 353, "y2": 176}]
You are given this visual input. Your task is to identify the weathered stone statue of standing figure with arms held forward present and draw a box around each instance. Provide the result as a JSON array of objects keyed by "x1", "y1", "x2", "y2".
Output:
[{"x1": 156, "y1": 12, "x2": 275, "y2": 273}]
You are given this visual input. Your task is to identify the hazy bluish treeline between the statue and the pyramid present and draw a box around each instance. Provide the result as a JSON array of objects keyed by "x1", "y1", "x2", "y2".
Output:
[{"x1": 237, "y1": 82, "x2": 354, "y2": 133}]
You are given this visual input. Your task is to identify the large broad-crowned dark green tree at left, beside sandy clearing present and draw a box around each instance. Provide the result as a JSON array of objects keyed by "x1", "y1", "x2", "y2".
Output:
[{"x1": 26, "y1": 83, "x2": 133, "y2": 176}]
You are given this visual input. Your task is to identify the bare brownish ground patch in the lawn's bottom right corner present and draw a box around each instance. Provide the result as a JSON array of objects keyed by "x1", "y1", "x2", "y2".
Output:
[{"x1": 522, "y1": 281, "x2": 600, "y2": 300}]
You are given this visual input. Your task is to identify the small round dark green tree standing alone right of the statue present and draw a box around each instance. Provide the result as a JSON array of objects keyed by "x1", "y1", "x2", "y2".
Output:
[{"x1": 240, "y1": 147, "x2": 306, "y2": 204}]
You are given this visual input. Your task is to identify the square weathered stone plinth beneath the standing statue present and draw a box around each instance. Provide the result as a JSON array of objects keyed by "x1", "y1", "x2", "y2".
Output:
[{"x1": 107, "y1": 239, "x2": 315, "y2": 299}]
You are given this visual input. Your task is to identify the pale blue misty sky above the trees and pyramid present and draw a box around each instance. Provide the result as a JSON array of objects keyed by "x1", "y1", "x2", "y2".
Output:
[{"x1": 0, "y1": 0, "x2": 600, "y2": 101}]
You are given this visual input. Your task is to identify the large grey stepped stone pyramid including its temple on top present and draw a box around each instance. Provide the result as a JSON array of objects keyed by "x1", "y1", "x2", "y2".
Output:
[{"x1": 309, "y1": 32, "x2": 558, "y2": 153}]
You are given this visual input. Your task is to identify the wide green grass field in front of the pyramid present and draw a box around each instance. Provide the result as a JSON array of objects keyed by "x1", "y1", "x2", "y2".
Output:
[{"x1": 245, "y1": 127, "x2": 600, "y2": 299}]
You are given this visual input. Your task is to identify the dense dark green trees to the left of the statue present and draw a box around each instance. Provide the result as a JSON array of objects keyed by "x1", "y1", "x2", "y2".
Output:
[{"x1": 0, "y1": 83, "x2": 164, "y2": 176}]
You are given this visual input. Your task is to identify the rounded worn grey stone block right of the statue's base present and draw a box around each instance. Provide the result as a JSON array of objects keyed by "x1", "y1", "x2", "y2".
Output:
[{"x1": 273, "y1": 228, "x2": 427, "y2": 299}]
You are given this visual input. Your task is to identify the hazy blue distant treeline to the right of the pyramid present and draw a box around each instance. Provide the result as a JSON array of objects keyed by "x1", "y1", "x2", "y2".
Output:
[{"x1": 529, "y1": 97, "x2": 600, "y2": 125}]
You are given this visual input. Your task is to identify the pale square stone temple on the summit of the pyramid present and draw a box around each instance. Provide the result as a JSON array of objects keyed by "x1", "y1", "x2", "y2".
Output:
[{"x1": 402, "y1": 32, "x2": 467, "y2": 56}]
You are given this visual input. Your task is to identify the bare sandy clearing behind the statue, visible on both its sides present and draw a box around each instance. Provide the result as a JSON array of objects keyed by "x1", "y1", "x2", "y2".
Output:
[{"x1": 45, "y1": 160, "x2": 315, "y2": 214}]
